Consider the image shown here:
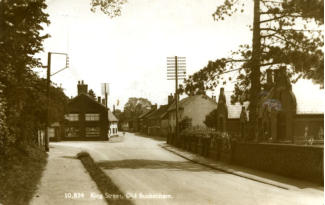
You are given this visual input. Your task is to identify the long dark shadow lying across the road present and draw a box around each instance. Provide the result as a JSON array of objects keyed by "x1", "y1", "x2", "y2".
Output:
[{"x1": 97, "y1": 159, "x2": 220, "y2": 173}]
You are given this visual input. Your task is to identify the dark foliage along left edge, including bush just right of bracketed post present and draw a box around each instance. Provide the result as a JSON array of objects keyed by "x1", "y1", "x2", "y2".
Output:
[{"x1": 0, "y1": 0, "x2": 68, "y2": 154}]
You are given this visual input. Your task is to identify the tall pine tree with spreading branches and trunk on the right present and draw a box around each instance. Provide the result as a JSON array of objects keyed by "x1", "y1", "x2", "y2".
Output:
[{"x1": 180, "y1": 0, "x2": 324, "y2": 138}]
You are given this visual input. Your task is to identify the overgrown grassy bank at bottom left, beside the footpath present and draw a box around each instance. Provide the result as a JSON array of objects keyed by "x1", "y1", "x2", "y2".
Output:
[{"x1": 0, "y1": 146, "x2": 47, "y2": 205}]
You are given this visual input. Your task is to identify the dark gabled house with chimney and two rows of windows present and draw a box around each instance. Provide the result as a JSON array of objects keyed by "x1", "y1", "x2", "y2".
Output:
[{"x1": 62, "y1": 81, "x2": 109, "y2": 140}]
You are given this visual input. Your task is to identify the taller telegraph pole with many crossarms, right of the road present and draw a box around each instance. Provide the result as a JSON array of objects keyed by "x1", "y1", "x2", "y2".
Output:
[{"x1": 167, "y1": 56, "x2": 186, "y2": 139}]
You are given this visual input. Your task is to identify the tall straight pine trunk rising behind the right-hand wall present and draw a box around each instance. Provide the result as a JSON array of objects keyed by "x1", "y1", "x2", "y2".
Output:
[{"x1": 249, "y1": 0, "x2": 261, "y2": 140}]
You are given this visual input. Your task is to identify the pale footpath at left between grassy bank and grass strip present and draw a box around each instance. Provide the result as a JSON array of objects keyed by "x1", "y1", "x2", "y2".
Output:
[{"x1": 30, "y1": 143, "x2": 106, "y2": 205}]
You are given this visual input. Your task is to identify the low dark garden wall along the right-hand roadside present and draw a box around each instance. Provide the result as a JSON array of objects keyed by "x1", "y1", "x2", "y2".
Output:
[{"x1": 231, "y1": 142, "x2": 324, "y2": 184}]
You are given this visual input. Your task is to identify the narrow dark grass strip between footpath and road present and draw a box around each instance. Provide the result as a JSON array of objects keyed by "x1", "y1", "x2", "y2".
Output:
[{"x1": 77, "y1": 152, "x2": 133, "y2": 205}]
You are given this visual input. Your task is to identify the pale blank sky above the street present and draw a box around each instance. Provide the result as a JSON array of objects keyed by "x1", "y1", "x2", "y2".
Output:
[{"x1": 38, "y1": 0, "x2": 322, "y2": 109}]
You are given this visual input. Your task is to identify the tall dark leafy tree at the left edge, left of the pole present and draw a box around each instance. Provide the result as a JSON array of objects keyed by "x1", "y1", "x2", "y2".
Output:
[{"x1": 0, "y1": 0, "x2": 50, "y2": 148}]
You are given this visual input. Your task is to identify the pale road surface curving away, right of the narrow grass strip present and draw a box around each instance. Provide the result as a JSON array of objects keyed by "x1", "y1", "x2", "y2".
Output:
[{"x1": 54, "y1": 133, "x2": 324, "y2": 205}]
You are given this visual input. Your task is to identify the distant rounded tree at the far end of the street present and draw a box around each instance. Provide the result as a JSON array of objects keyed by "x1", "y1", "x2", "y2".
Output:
[{"x1": 124, "y1": 97, "x2": 151, "y2": 119}]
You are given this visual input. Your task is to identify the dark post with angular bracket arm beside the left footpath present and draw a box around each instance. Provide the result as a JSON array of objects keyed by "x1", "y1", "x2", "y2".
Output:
[{"x1": 43, "y1": 52, "x2": 69, "y2": 152}]
